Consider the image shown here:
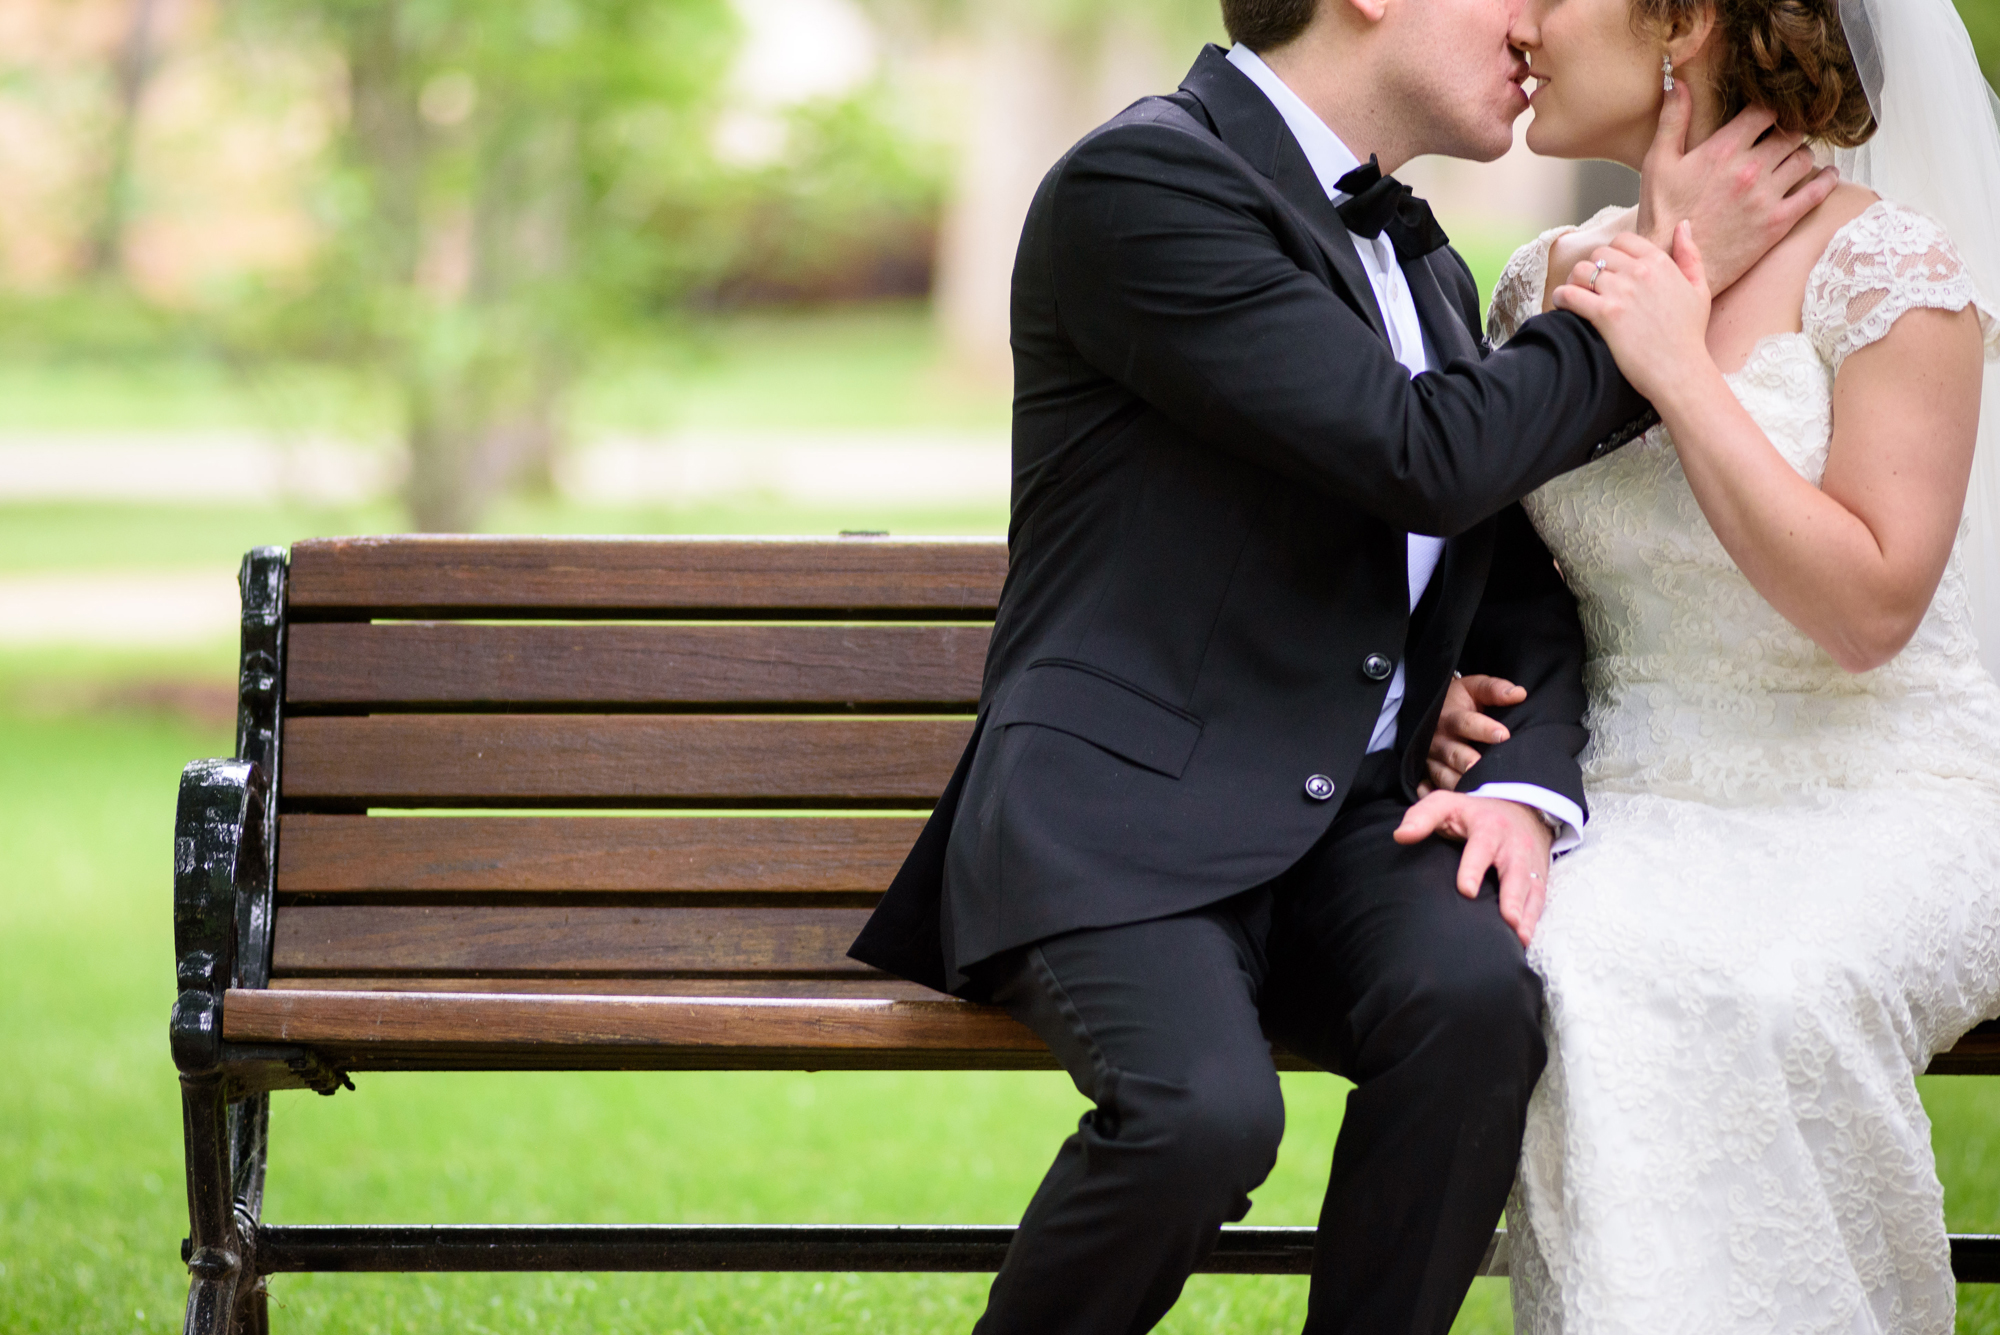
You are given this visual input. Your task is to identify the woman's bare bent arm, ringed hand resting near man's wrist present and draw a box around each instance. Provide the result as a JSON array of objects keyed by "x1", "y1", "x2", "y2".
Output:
[{"x1": 1554, "y1": 230, "x2": 1982, "y2": 671}]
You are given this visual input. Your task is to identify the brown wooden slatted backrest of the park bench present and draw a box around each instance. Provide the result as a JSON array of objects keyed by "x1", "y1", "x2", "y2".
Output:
[{"x1": 270, "y1": 538, "x2": 1006, "y2": 997}]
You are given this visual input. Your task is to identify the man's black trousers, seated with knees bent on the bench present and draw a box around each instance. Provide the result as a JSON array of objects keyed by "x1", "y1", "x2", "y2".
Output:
[{"x1": 976, "y1": 757, "x2": 1546, "y2": 1335}]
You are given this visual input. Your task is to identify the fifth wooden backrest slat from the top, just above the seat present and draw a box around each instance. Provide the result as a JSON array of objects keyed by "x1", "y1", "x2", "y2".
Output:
[{"x1": 272, "y1": 903, "x2": 876, "y2": 977}]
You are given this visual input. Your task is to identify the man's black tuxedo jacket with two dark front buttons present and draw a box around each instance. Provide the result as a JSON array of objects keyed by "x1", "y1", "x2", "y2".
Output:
[{"x1": 852, "y1": 46, "x2": 1652, "y2": 993}]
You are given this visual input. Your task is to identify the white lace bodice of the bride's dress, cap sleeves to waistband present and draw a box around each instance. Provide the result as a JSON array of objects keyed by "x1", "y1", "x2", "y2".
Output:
[{"x1": 1490, "y1": 202, "x2": 2000, "y2": 801}]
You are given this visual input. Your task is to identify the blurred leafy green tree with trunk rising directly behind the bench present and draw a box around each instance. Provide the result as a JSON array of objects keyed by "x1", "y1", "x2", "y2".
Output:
[{"x1": 235, "y1": 0, "x2": 736, "y2": 532}]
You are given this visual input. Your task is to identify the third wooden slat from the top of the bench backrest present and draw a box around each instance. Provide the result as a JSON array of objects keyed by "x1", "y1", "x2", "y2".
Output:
[{"x1": 282, "y1": 713, "x2": 972, "y2": 807}]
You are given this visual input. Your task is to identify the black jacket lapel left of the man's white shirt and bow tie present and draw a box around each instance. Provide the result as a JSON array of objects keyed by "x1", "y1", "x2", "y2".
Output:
[{"x1": 1180, "y1": 46, "x2": 1388, "y2": 342}]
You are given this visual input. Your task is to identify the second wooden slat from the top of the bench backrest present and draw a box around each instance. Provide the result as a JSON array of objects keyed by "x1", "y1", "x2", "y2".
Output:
[{"x1": 284, "y1": 622, "x2": 992, "y2": 713}]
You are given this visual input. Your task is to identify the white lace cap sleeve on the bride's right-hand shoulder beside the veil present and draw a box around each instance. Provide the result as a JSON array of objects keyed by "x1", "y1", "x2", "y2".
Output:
[{"x1": 1800, "y1": 200, "x2": 2000, "y2": 372}]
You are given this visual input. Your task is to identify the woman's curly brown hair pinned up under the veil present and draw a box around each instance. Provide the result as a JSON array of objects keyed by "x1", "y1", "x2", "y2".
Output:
[{"x1": 1632, "y1": 0, "x2": 1876, "y2": 148}]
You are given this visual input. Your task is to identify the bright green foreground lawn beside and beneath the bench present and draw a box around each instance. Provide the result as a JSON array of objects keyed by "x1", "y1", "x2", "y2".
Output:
[{"x1": 11, "y1": 652, "x2": 2000, "y2": 1333}]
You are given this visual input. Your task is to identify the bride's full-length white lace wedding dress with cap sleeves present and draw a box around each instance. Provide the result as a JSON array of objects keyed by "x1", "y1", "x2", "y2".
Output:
[{"x1": 1492, "y1": 204, "x2": 2000, "y2": 1335}]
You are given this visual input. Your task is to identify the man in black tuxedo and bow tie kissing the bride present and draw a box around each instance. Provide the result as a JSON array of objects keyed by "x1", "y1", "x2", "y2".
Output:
[{"x1": 854, "y1": 0, "x2": 1830, "y2": 1335}]
